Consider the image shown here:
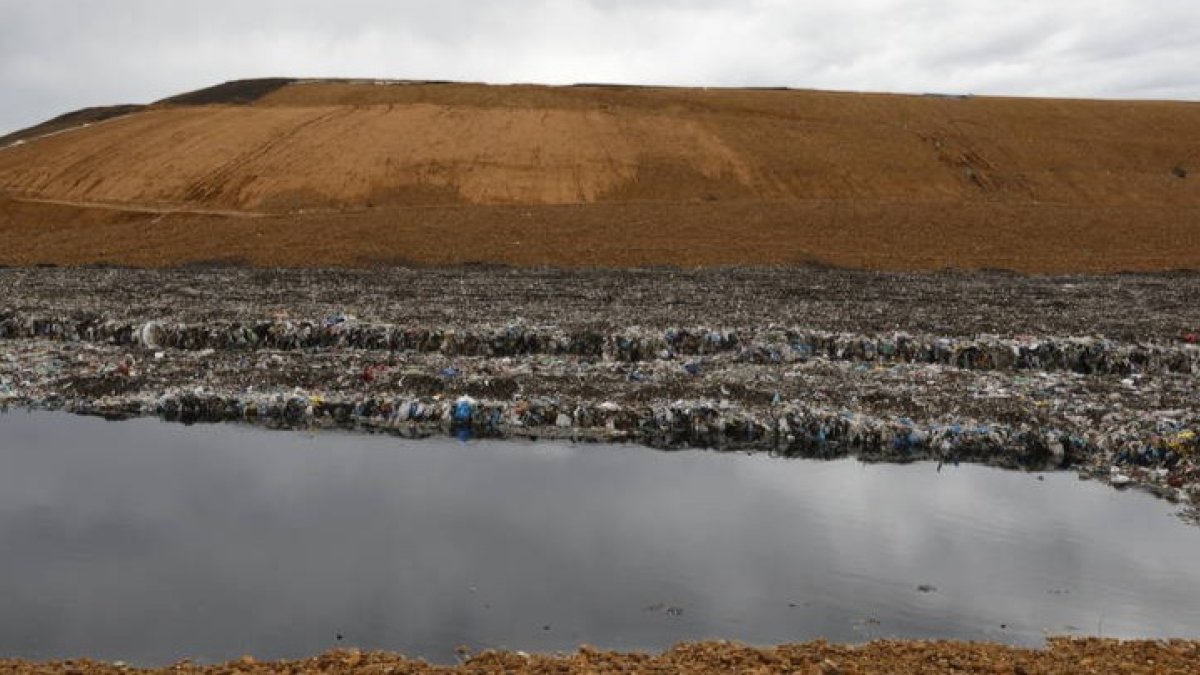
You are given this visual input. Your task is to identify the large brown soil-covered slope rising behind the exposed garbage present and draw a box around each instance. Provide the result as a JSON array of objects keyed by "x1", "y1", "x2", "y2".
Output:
[{"x1": 0, "y1": 80, "x2": 1200, "y2": 271}]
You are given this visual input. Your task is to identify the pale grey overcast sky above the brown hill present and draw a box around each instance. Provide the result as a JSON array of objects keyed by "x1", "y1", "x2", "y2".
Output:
[{"x1": 0, "y1": 0, "x2": 1200, "y2": 133}]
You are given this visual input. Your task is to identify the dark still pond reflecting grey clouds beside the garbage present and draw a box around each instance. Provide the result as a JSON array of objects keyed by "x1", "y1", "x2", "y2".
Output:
[{"x1": 0, "y1": 412, "x2": 1200, "y2": 664}]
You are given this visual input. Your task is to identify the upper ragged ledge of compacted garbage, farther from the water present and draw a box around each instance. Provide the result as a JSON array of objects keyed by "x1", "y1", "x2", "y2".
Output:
[{"x1": 0, "y1": 310, "x2": 1200, "y2": 375}]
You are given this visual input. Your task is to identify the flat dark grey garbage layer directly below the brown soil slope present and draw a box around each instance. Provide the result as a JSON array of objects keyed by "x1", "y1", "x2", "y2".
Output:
[{"x1": 0, "y1": 265, "x2": 1200, "y2": 342}]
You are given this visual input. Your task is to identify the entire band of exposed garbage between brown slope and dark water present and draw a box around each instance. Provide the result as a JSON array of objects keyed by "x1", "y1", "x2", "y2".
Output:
[{"x1": 0, "y1": 265, "x2": 1200, "y2": 509}]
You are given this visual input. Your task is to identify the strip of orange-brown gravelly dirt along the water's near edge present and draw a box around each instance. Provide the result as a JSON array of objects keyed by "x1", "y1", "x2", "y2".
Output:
[{"x1": 0, "y1": 639, "x2": 1200, "y2": 675}]
